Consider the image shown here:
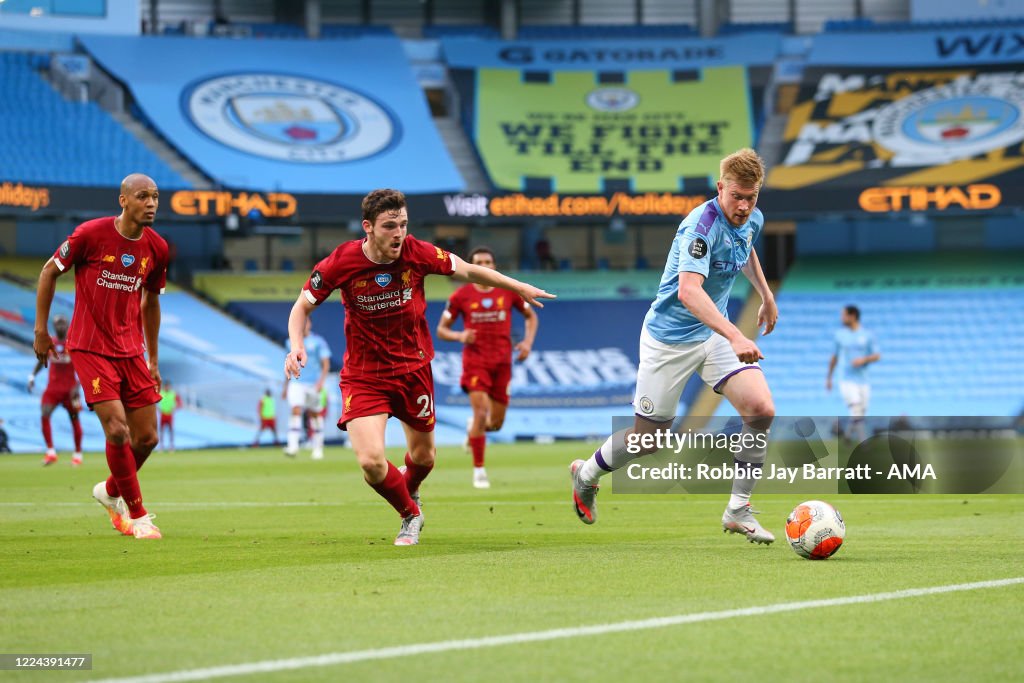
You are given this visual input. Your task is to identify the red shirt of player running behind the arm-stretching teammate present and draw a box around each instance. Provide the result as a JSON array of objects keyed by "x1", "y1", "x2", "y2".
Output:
[{"x1": 446, "y1": 285, "x2": 526, "y2": 367}]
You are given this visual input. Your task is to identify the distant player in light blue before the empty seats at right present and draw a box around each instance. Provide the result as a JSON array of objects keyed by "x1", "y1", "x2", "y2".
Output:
[{"x1": 825, "y1": 305, "x2": 882, "y2": 440}]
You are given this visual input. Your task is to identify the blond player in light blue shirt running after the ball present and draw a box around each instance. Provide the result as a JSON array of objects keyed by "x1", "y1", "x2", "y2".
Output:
[{"x1": 569, "y1": 148, "x2": 778, "y2": 544}]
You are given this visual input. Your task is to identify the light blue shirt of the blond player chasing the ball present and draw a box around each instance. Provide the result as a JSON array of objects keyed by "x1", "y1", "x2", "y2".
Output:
[{"x1": 643, "y1": 199, "x2": 764, "y2": 344}]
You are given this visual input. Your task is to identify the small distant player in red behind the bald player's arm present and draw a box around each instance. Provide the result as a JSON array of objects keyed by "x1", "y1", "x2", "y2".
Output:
[{"x1": 29, "y1": 315, "x2": 82, "y2": 467}]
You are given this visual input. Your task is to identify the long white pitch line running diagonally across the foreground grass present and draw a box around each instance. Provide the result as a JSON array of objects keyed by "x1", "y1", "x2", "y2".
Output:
[{"x1": 94, "y1": 577, "x2": 1024, "y2": 683}]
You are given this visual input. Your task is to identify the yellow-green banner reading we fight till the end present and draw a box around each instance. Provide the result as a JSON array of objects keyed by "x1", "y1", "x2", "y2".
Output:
[{"x1": 470, "y1": 66, "x2": 754, "y2": 194}]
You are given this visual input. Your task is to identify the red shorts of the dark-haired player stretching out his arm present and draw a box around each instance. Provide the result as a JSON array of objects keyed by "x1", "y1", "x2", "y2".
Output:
[{"x1": 338, "y1": 362, "x2": 435, "y2": 432}]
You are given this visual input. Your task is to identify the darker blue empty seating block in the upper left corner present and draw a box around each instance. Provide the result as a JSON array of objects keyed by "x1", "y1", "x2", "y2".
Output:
[{"x1": 0, "y1": 52, "x2": 190, "y2": 188}]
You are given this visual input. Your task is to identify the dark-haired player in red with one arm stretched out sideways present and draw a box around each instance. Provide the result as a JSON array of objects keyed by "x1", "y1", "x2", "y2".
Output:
[{"x1": 285, "y1": 189, "x2": 553, "y2": 546}]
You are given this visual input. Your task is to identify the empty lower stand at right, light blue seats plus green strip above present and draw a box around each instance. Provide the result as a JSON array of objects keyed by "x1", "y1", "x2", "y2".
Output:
[{"x1": 757, "y1": 253, "x2": 1024, "y2": 417}]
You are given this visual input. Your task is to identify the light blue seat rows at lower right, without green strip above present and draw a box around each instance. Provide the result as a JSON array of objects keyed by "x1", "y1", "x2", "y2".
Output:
[{"x1": 745, "y1": 287, "x2": 1024, "y2": 416}]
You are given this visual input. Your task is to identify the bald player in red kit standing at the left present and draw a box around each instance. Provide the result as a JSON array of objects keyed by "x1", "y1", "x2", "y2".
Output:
[{"x1": 33, "y1": 173, "x2": 167, "y2": 539}]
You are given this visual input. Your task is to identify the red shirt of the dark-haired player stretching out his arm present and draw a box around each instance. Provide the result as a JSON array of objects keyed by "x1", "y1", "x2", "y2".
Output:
[{"x1": 303, "y1": 236, "x2": 455, "y2": 378}]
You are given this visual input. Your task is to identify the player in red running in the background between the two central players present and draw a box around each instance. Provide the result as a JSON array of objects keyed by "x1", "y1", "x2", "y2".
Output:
[{"x1": 437, "y1": 247, "x2": 538, "y2": 488}]
